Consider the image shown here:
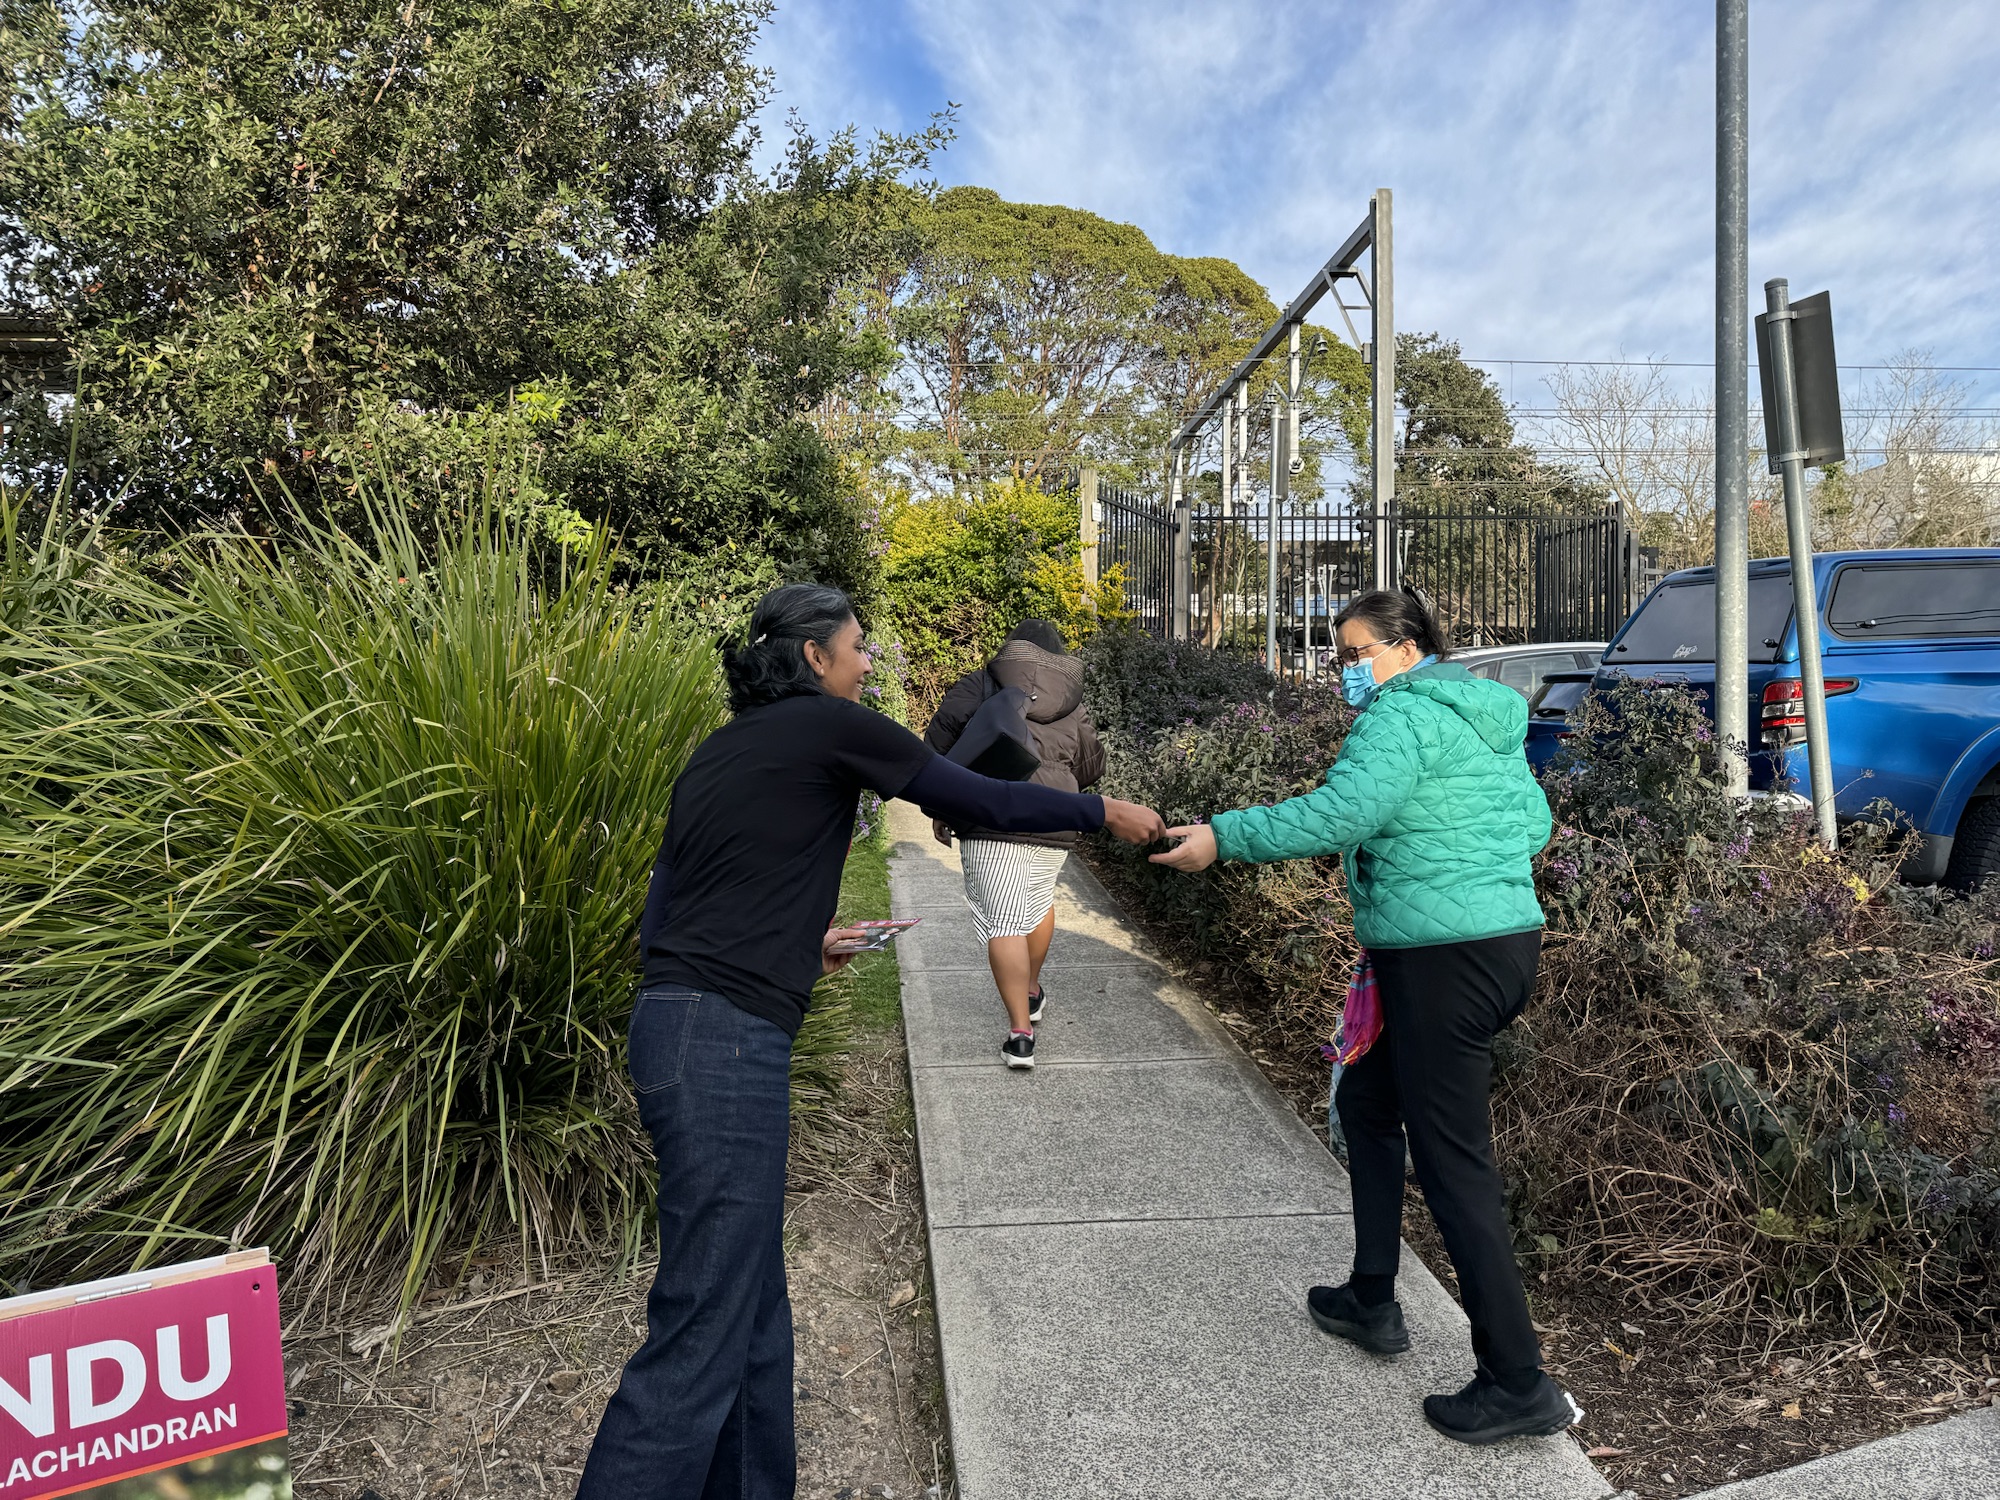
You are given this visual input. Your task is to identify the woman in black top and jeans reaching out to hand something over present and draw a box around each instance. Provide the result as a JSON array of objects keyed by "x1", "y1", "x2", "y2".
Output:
[{"x1": 578, "y1": 584, "x2": 1164, "y2": 1500}]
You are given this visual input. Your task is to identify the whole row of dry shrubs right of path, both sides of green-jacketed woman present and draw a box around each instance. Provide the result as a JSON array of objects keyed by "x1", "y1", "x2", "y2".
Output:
[{"x1": 1088, "y1": 636, "x2": 2000, "y2": 1338}]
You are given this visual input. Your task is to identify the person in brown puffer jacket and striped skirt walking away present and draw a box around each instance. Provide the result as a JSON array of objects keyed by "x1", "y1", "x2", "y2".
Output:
[{"x1": 924, "y1": 620, "x2": 1104, "y2": 1068}]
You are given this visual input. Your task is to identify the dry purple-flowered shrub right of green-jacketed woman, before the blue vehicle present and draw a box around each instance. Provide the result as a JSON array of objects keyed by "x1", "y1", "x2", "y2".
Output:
[{"x1": 1496, "y1": 682, "x2": 2000, "y2": 1326}]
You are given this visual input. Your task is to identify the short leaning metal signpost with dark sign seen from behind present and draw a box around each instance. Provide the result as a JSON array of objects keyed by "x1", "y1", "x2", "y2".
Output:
[{"x1": 1758, "y1": 276, "x2": 1846, "y2": 848}]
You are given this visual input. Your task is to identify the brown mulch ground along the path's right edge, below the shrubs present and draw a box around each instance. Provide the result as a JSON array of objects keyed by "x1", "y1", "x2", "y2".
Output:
[{"x1": 1092, "y1": 860, "x2": 2000, "y2": 1500}]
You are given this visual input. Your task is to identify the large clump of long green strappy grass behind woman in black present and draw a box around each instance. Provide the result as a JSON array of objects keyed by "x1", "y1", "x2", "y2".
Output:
[{"x1": 0, "y1": 484, "x2": 844, "y2": 1300}]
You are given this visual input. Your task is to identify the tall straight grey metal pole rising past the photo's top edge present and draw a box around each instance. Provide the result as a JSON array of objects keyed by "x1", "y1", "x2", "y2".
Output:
[{"x1": 1716, "y1": 0, "x2": 1750, "y2": 796}]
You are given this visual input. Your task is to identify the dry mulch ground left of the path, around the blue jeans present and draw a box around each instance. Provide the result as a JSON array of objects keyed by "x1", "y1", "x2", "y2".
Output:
[{"x1": 286, "y1": 1030, "x2": 956, "y2": 1500}]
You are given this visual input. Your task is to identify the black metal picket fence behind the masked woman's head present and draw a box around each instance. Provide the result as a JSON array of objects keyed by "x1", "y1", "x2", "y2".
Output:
[{"x1": 1098, "y1": 486, "x2": 1646, "y2": 674}]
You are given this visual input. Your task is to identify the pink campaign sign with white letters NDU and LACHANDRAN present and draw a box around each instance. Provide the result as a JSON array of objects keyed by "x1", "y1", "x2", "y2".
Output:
[{"x1": 0, "y1": 1262, "x2": 284, "y2": 1500}]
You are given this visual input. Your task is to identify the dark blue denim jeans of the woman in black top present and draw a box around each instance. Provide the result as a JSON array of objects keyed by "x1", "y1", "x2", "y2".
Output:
[{"x1": 576, "y1": 986, "x2": 798, "y2": 1500}]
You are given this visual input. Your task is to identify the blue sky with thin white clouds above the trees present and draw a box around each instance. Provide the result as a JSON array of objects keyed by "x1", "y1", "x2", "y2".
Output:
[{"x1": 758, "y1": 0, "x2": 2000, "y2": 396}]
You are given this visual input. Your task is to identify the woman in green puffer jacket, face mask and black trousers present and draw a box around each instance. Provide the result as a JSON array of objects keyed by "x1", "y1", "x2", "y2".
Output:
[{"x1": 1152, "y1": 592, "x2": 1580, "y2": 1442}]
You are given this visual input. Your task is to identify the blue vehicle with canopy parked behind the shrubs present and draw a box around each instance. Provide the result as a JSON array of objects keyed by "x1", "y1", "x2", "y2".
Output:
[{"x1": 1596, "y1": 548, "x2": 2000, "y2": 888}]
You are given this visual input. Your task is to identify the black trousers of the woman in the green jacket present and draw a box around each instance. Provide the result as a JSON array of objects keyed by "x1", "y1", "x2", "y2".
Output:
[{"x1": 1334, "y1": 932, "x2": 1542, "y2": 1376}]
